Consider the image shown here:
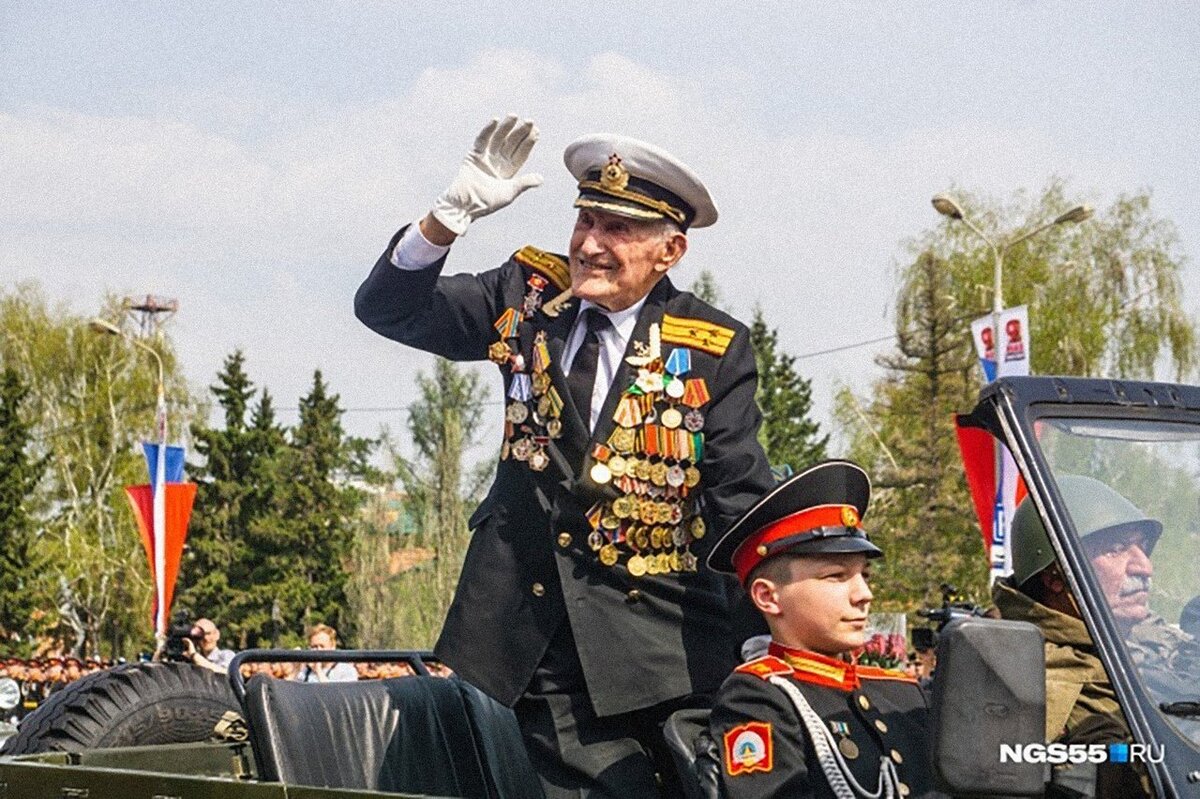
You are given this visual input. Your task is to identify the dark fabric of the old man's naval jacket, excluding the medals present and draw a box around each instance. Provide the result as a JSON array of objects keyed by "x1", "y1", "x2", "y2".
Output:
[{"x1": 355, "y1": 224, "x2": 772, "y2": 716}]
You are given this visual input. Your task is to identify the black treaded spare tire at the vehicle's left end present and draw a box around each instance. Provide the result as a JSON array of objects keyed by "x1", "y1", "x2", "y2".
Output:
[{"x1": 0, "y1": 662, "x2": 240, "y2": 755}]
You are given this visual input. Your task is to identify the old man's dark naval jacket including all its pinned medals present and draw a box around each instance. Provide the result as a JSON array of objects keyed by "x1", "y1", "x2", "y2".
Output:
[{"x1": 355, "y1": 225, "x2": 772, "y2": 716}]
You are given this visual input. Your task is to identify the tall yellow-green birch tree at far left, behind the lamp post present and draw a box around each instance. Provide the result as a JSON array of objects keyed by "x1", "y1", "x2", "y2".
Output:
[{"x1": 0, "y1": 286, "x2": 196, "y2": 655}]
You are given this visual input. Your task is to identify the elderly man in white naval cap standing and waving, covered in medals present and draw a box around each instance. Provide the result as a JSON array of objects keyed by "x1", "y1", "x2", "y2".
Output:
[{"x1": 355, "y1": 116, "x2": 772, "y2": 799}]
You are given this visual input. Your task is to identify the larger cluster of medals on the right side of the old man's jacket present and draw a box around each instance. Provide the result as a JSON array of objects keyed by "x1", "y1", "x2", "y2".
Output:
[{"x1": 588, "y1": 324, "x2": 709, "y2": 577}]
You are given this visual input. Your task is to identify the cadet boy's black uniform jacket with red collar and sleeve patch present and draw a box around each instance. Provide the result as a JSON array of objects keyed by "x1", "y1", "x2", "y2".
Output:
[{"x1": 709, "y1": 643, "x2": 941, "y2": 799}]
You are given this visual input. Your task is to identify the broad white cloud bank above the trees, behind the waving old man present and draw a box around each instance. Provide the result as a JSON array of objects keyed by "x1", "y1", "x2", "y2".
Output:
[{"x1": 0, "y1": 49, "x2": 1180, "y2": 451}]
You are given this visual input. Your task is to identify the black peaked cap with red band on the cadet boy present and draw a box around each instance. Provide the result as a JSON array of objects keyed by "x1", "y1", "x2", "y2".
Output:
[{"x1": 708, "y1": 461, "x2": 883, "y2": 583}]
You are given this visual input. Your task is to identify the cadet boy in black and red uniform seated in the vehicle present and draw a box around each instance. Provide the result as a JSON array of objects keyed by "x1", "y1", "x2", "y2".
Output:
[{"x1": 708, "y1": 461, "x2": 937, "y2": 799}]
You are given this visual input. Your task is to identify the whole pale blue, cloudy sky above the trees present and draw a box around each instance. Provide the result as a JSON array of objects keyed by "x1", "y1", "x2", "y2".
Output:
[{"x1": 0, "y1": 0, "x2": 1200, "y2": 453}]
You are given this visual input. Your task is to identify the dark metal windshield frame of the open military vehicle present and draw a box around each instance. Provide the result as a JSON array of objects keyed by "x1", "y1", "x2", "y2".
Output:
[{"x1": 967, "y1": 377, "x2": 1200, "y2": 795}]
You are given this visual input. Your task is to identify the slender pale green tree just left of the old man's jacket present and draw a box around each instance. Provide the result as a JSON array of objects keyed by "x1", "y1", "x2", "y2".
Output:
[{"x1": 352, "y1": 359, "x2": 491, "y2": 648}]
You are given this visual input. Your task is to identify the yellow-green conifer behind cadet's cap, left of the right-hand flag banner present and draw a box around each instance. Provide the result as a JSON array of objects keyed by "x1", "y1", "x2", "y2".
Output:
[{"x1": 838, "y1": 253, "x2": 988, "y2": 611}]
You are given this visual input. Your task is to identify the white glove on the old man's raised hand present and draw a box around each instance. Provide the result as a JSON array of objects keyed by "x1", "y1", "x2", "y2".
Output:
[{"x1": 433, "y1": 114, "x2": 541, "y2": 236}]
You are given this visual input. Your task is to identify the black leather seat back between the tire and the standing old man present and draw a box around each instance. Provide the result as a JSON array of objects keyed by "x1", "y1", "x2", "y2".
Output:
[{"x1": 245, "y1": 675, "x2": 542, "y2": 799}]
